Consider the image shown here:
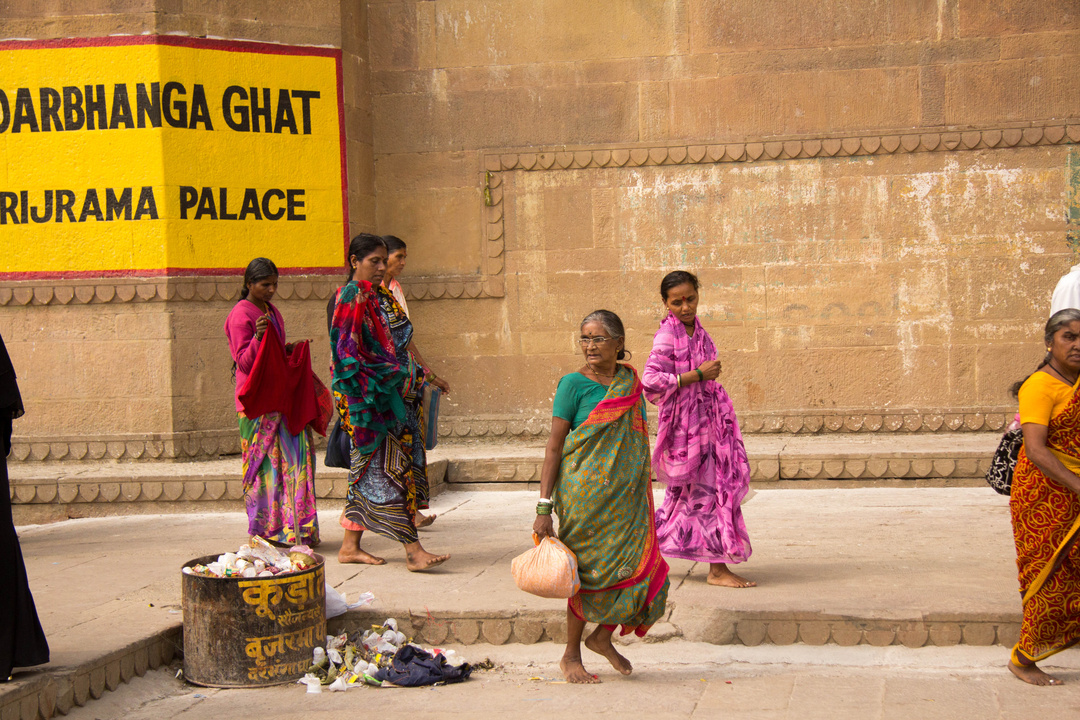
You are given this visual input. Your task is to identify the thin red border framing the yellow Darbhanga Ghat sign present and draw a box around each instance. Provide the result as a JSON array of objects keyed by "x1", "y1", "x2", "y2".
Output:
[{"x1": 0, "y1": 35, "x2": 349, "y2": 281}]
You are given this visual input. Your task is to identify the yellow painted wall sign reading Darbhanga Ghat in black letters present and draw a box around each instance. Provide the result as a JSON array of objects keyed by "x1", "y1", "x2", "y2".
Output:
[{"x1": 0, "y1": 36, "x2": 348, "y2": 279}]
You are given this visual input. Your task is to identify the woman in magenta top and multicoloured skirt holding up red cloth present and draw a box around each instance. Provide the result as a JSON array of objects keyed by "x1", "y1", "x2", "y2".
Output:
[{"x1": 225, "y1": 258, "x2": 319, "y2": 547}]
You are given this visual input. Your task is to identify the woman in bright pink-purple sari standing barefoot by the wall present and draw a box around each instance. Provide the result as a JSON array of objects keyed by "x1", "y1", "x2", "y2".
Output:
[{"x1": 642, "y1": 270, "x2": 757, "y2": 587}]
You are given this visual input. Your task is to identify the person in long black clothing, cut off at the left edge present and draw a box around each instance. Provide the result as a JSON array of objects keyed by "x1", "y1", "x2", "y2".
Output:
[{"x1": 0, "y1": 336, "x2": 49, "y2": 682}]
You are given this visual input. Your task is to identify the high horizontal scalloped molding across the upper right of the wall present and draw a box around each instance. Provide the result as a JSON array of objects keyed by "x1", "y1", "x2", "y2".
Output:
[{"x1": 484, "y1": 120, "x2": 1080, "y2": 174}]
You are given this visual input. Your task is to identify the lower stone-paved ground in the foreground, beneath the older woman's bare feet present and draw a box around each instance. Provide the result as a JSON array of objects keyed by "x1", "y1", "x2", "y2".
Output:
[{"x1": 59, "y1": 641, "x2": 1080, "y2": 720}]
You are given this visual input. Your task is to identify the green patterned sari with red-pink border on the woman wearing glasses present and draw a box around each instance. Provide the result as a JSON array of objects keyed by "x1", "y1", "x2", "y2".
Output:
[{"x1": 554, "y1": 365, "x2": 669, "y2": 636}]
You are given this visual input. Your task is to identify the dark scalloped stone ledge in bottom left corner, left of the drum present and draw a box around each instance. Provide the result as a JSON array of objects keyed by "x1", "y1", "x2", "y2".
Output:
[{"x1": 0, "y1": 623, "x2": 184, "y2": 720}]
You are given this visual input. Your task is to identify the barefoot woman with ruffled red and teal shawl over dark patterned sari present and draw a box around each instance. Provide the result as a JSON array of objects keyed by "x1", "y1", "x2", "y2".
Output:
[{"x1": 329, "y1": 233, "x2": 450, "y2": 571}]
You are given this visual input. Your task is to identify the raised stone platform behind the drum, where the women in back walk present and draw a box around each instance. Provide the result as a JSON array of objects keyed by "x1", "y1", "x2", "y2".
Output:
[{"x1": 0, "y1": 488, "x2": 1020, "y2": 716}]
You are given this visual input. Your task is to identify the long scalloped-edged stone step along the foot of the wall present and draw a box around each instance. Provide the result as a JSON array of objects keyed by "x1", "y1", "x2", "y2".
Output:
[{"x1": 9, "y1": 433, "x2": 1000, "y2": 525}]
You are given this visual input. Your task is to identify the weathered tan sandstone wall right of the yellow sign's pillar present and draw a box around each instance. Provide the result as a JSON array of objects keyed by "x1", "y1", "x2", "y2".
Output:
[{"x1": 369, "y1": 0, "x2": 1080, "y2": 438}]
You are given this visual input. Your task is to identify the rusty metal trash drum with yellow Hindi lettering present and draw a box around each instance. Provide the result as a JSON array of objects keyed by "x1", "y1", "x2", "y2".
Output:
[{"x1": 180, "y1": 555, "x2": 326, "y2": 688}]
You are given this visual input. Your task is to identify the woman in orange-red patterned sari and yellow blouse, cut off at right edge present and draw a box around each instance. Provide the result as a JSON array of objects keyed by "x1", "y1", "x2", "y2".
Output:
[{"x1": 1009, "y1": 309, "x2": 1080, "y2": 685}]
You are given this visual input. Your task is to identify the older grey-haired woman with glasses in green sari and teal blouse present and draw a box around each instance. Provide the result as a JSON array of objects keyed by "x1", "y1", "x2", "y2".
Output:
[{"x1": 532, "y1": 310, "x2": 667, "y2": 683}]
